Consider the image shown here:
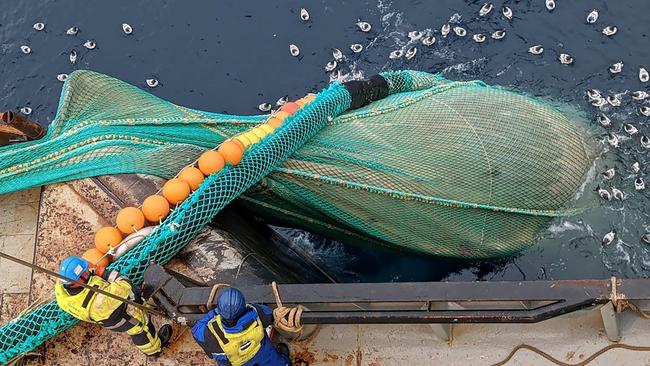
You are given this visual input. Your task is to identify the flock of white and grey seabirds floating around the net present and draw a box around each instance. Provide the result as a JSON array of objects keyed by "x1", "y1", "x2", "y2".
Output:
[{"x1": 12, "y1": 0, "x2": 650, "y2": 245}]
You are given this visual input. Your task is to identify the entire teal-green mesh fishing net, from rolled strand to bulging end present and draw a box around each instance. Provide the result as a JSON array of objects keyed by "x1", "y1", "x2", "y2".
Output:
[{"x1": 0, "y1": 71, "x2": 591, "y2": 362}]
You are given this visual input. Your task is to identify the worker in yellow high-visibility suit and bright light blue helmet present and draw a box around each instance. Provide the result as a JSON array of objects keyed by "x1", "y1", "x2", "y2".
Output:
[{"x1": 55, "y1": 257, "x2": 172, "y2": 356}]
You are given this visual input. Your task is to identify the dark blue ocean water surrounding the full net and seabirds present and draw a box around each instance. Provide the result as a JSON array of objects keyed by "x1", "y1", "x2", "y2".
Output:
[{"x1": 0, "y1": 0, "x2": 650, "y2": 281}]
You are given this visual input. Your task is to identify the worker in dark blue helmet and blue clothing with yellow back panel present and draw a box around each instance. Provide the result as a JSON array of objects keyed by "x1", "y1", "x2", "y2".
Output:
[{"x1": 192, "y1": 287, "x2": 291, "y2": 366}]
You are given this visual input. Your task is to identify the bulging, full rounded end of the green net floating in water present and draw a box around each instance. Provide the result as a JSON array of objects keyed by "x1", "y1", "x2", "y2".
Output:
[{"x1": 239, "y1": 80, "x2": 591, "y2": 258}]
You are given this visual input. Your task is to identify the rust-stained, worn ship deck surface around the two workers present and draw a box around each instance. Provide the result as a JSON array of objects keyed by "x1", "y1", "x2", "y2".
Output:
[{"x1": 0, "y1": 175, "x2": 650, "y2": 366}]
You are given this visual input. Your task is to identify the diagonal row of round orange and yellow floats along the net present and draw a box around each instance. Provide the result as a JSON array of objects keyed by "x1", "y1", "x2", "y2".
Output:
[{"x1": 82, "y1": 93, "x2": 316, "y2": 267}]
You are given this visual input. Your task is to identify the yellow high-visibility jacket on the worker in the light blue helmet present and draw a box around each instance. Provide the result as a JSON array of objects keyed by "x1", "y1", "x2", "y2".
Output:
[{"x1": 54, "y1": 275, "x2": 132, "y2": 323}]
